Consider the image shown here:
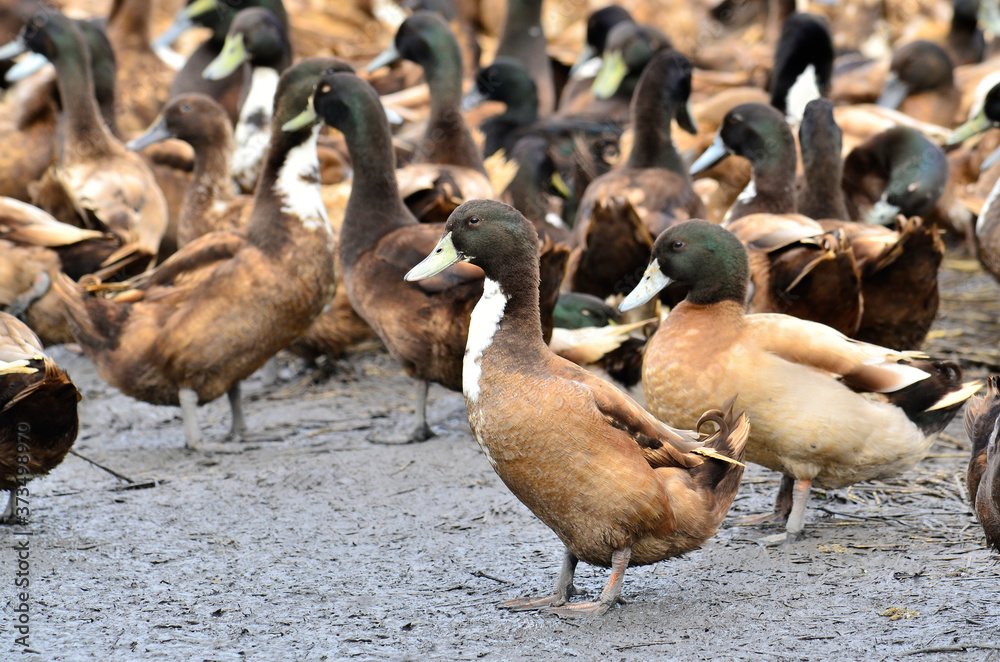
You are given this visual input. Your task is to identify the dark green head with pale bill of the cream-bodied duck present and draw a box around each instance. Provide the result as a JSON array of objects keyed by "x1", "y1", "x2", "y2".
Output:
[{"x1": 618, "y1": 220, "x2": 750, "y2": 312}]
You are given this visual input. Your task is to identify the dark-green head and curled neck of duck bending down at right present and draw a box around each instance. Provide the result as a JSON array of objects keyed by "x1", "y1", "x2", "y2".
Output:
[{"x1": 842, "y1": 126, "x2": 948, "y2": 225}]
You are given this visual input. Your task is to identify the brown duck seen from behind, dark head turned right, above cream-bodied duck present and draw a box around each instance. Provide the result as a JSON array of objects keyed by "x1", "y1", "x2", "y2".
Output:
[{"x1": 565, "y1": 50, "x2": 705, "y2": 297}]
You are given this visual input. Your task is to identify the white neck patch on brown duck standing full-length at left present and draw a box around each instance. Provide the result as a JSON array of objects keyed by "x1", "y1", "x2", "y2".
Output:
[{"x1": 274, "y1": 123, "x2": 333, "y2": 234}]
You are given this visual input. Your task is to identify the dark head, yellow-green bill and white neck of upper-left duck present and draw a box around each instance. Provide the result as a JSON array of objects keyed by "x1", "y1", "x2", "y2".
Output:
[{"x1": 202, "y1": 7, "x2": 292, "y2": 194}]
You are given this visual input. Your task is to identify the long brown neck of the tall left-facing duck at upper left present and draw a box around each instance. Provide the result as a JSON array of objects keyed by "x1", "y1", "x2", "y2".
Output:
[{"x1": 54, "y1": 44, "x2": 113, "y2": 158}]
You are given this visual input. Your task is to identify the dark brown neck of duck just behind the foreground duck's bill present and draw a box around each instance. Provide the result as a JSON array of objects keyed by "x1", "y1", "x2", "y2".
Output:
[{"x1": 337, "y1": 107, "x2": 417, "y2": 270}]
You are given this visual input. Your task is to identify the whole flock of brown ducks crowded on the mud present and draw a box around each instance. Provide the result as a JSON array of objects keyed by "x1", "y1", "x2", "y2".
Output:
[{"x1": 0, "y1": 0, "x2": 1000, "y2": 614}]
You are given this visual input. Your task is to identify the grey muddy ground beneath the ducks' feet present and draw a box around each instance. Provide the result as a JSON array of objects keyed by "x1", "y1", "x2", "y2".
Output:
[{"x1": 0, "y1": 260, "x2": 1000, "y2": 661}]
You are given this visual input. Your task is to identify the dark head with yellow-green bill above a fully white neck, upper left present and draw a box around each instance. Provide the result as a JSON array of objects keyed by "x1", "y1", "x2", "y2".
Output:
[{"x1": 202, "y1": 7, "x2": 292, "y2": 80}]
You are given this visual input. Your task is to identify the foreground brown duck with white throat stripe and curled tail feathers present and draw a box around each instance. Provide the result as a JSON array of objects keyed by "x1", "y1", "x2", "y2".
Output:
[{"x1": 406, "y1": 200, "x2": 749, "y2": 617}]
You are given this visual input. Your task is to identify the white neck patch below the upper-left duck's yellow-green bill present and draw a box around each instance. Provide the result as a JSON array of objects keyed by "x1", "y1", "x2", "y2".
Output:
[{"x1": 229, "y1": 67, "x2": 280, "y2": 191}]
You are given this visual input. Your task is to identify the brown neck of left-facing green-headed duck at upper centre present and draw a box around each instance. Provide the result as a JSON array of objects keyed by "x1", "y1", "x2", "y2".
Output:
[{"x1": 414, "y1": 46, "x2": 486, "y2": 174}]
